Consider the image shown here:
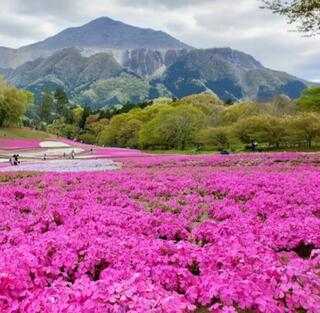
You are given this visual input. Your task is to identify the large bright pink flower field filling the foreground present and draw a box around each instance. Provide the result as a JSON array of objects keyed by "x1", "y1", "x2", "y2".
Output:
[{"x1": 0, "y1": 153, "x2": 320, "y2": 313}]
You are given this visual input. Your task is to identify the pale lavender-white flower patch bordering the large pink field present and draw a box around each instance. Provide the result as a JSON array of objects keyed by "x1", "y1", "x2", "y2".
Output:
[{"x1": 0, "y1": 159, "x2": 120, "y2": 173}]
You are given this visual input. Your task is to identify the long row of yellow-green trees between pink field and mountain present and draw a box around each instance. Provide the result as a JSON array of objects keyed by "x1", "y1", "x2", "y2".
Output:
[{"x1": 43, "y1": 87, "x2": 320, "y2": 150}]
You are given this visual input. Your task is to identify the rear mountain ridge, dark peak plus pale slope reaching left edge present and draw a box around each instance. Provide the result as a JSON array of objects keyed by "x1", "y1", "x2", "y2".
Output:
[{"x1": 0, "y1": 17, "x2": 192, "y2": 68}]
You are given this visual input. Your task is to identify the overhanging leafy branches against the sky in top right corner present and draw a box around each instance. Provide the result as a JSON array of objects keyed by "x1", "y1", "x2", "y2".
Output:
[{"x1": 262, "y1": 0, "x2": 320, "y2": 34}]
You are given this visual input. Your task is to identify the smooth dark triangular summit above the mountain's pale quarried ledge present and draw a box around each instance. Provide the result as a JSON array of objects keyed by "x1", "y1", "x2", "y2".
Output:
[{"x1": 22, "y1": 17, "x2": 191, "y2": 50}]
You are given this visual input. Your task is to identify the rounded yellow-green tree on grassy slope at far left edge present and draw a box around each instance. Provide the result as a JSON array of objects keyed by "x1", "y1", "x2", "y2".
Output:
[{"x1": 0, "y1": 77, "x2": 33, "y2": 127}]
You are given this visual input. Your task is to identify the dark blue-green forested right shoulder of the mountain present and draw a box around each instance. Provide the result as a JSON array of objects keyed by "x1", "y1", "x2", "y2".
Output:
[{"x1": 163, "y1": 48, "x2": 310, "y2": 100}]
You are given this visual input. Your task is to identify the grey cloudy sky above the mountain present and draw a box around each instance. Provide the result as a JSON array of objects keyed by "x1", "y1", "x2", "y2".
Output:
[{"x1": 0, "y1": 0, "x2": 320, "y2": 81}]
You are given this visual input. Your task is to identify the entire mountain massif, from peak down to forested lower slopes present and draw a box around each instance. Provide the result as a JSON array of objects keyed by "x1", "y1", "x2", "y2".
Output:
[{"x1": 0, "y1": 17, "x2": 312, "y2": 108}]
